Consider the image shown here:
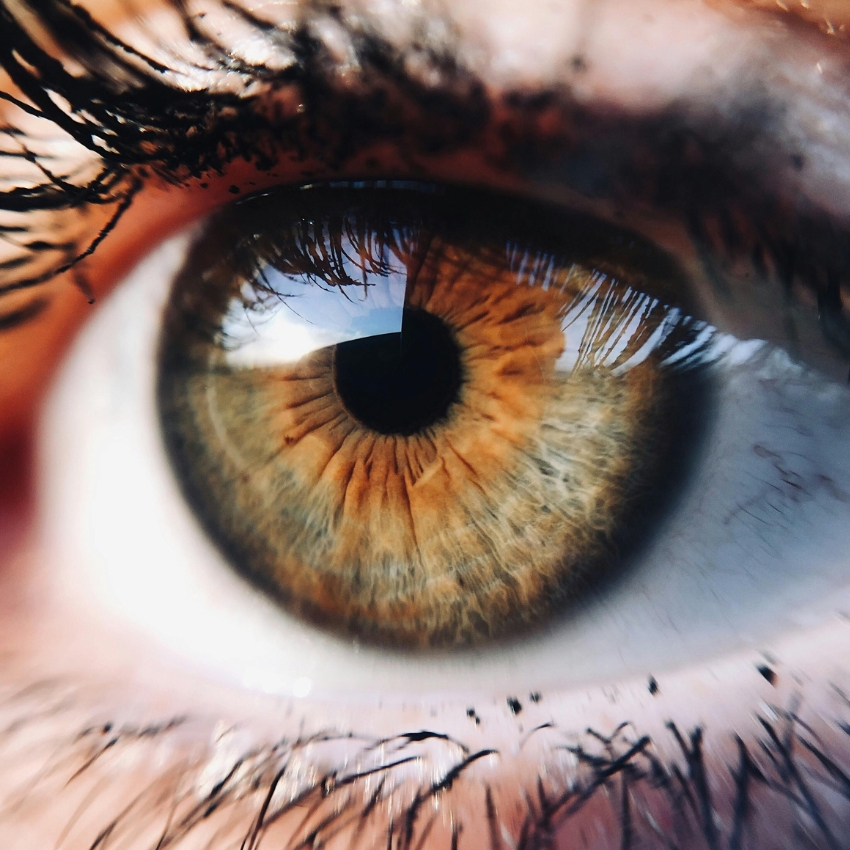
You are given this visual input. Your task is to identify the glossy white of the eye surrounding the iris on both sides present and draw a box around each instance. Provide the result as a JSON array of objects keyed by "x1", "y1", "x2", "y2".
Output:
[{"x1": 39, "y1": 225, "x2": 850, "y2": 699}]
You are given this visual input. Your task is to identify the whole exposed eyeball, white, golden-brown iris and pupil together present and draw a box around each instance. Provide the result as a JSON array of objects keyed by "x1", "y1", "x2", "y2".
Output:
[{"x1": 34, "y1": 169, "x2": 850, "y2": 693}]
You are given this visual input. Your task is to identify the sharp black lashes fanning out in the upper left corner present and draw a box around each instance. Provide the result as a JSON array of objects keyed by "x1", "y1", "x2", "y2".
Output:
[{"x1": 0, "y1": 0, "x2": 480, "y2": 294}]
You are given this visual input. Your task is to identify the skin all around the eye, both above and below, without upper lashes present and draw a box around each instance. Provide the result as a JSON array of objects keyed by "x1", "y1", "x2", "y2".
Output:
[{"x1": 0, "y1": 0, "x2": 850, "y2": 850}]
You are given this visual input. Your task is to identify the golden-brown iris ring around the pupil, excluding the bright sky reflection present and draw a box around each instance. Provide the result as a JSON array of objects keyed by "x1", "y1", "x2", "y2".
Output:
[{"x1": 160, "y1": 188, "x2": 704, "y2": 646}]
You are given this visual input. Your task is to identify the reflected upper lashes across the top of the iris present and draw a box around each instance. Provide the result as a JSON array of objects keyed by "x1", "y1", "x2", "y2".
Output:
[{"x1": 200, "y1": 187, "x2": 713, "y2": 370}]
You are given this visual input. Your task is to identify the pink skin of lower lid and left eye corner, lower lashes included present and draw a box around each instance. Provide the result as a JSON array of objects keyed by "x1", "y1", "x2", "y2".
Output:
[{"x1": 0, "y1": 1, "x2": 850, "y2": 850}]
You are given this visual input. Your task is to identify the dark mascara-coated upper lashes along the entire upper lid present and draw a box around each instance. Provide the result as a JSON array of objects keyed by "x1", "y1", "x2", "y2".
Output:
[{"x1": 0, "y1": 0, "x2": 850, "y2": 366}]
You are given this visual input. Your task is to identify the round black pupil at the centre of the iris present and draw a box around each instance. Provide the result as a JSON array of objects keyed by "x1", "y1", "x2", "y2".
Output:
[{"x1": 334, "y1": 310, "x2": 461, "y2": 435}]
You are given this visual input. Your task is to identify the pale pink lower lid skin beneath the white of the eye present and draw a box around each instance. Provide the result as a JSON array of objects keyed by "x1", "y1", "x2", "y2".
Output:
[{"x1": 0, "y1": 548, "x2": 850, "y2": 850}]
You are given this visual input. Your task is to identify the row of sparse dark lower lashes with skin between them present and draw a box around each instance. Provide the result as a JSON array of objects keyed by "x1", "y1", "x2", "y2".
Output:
[{"x1": 0, "y1": 668, "x2": 850, "y2": 850}]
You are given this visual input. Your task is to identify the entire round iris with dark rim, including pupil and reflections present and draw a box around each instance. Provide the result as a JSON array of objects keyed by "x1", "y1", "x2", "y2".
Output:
[{"x1": 158, "y1": 183, "x2": 714, "y2": 647}]
